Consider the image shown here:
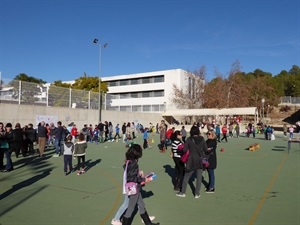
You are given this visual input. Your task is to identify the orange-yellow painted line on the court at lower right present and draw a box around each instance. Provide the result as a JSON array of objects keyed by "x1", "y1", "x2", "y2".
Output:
[{"x1": 248, "y1": 154, "x2": 288, "y2": 225}]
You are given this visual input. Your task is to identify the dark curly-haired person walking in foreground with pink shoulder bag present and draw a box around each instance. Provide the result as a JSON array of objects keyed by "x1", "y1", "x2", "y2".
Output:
[{"x1": 122, "y1": 144, "x2": 159, "y2": 225}]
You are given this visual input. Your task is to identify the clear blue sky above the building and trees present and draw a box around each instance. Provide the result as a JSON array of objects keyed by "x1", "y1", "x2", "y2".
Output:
[{"x1": 0, "y1": 0, "x2": 300, "y2": 82}]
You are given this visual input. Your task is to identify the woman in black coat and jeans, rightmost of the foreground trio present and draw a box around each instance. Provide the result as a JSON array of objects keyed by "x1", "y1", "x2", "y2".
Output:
[{"x1": 206, "y1": 131, "x2": 217, "y2": 193}]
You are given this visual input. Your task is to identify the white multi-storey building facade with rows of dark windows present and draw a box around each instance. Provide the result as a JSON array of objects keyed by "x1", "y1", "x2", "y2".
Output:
[{"x1": 101, "y1": 69, "x2": 191, "y2": 113}]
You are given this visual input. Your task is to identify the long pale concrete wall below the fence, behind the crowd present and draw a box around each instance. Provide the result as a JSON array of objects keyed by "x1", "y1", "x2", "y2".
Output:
[{"x1": 0, "y1": 103, "x2": 163, "y2": 128}]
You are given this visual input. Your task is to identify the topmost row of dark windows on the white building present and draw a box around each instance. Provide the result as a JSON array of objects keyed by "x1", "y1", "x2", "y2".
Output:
[{"x1": 107, "y1": 75, "x2": 165, "y2": 87}]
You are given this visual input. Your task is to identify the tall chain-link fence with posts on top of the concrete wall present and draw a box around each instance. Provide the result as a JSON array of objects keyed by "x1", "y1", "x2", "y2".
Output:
[{"x1": 0, "y1": 80, "x2": 102, "y2": 109}]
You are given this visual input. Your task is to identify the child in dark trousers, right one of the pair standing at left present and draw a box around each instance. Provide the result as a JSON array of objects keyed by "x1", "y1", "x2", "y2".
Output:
[{"x1": 74, "y1": 133, "x2": 87, "y2": 175}]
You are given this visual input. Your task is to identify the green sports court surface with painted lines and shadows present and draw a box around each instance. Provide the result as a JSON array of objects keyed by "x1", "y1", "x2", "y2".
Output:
[{"x1": 0, "y1": 134, "x2": 300, "y2": 225}]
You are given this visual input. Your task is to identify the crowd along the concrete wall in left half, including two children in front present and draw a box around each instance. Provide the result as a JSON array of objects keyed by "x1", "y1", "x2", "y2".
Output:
[{"x1": 0, "y1": 121, "x2": 148, "y2": 175}]
